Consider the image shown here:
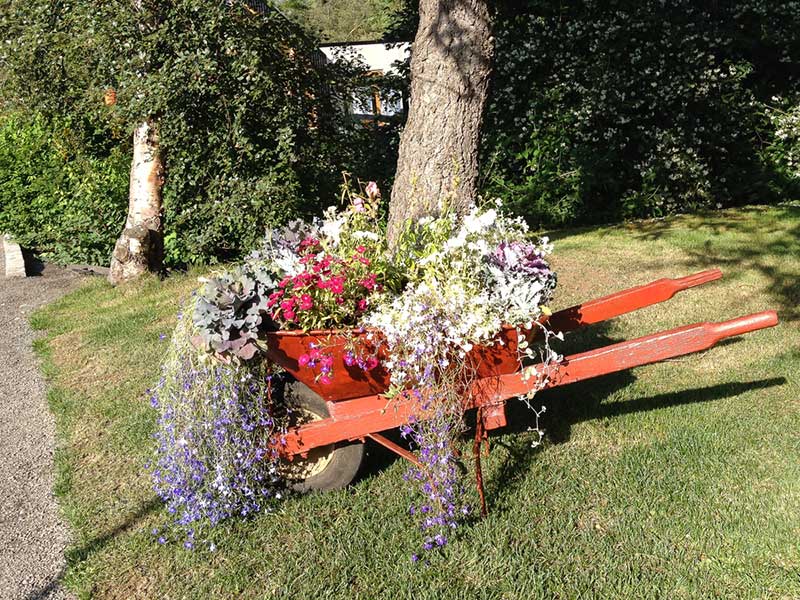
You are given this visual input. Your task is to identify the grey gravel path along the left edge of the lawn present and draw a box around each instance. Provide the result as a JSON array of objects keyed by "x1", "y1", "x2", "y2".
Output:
[{"x1": 0, "y1": 244, "x2": 80, "y2": 600}]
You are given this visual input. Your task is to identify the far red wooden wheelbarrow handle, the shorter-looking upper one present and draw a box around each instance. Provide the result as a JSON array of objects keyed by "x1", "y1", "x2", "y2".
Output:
[{"x1": 548, "y1": 269, "x2": 722, "y2": 332}]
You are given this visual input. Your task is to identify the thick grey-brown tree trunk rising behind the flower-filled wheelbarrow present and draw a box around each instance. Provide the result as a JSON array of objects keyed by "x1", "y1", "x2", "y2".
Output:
[{"x1": 388, "y1": 0, "x2": 493, "y2": 244}]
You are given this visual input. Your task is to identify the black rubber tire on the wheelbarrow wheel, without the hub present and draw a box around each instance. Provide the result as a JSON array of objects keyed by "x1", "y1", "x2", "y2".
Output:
[{"x1": 284, "y1": 381, "x2": 364, "y2": 494}]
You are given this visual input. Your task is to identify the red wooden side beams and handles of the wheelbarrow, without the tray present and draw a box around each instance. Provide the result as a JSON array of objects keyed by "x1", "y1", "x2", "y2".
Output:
[{"x1": 278, "y1": 269, "x2": 778, "y2": 463}]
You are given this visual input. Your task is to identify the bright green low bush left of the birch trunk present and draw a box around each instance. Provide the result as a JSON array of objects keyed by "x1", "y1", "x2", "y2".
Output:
[{"x1": 0, "y1": 116, "x2": 130, "y2": 264}]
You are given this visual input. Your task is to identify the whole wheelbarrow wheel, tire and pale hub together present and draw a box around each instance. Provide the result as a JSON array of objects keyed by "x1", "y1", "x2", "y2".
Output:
[{"x1": 282, "y1": 381, "x2": 364, "y2": 493}]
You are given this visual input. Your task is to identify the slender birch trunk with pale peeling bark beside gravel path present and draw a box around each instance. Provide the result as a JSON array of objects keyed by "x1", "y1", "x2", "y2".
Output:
[{"x1": 108, "y1": 119, "x2": 164, "y2": 285}]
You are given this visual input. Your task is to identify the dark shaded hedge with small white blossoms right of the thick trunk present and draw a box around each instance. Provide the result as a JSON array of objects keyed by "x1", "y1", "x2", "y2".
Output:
[{"x1": 483, "y1": 0, "x2": 800, "y2": 225}]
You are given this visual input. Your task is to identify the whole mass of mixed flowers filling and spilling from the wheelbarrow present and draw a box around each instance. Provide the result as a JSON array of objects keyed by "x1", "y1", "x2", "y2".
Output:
[{"x1": 153, "y1": 183, "x2": 558, "y2": 559}]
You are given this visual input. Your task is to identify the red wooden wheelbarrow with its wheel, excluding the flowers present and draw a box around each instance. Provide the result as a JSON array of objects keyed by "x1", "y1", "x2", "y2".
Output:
[{"x1": 267, "y1": 269, "x2": 778, "y2": 491}]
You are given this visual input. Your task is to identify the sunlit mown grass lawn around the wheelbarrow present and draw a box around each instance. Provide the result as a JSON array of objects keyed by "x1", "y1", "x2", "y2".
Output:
[{"x1": 32, "y1": 204, "x2": 800, "y2": 599}]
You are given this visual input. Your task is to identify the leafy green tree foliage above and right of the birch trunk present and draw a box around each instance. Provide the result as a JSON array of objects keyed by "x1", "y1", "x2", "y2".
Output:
[{"x1": 0, "y1": 0, "x2": 362, "y2": 265}]
